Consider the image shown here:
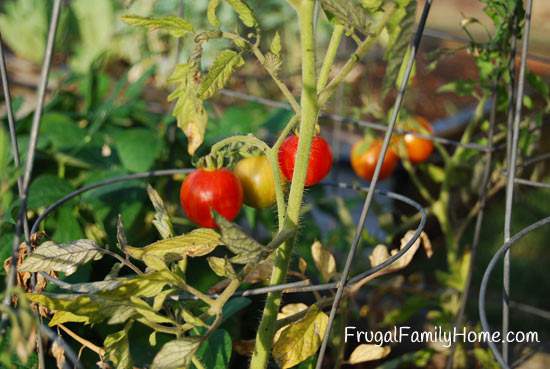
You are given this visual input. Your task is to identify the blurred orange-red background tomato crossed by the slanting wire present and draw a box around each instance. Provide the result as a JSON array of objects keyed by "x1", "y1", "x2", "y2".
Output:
[{"x1": 351, "y1": 140, "x2": 399, "y2": 181}]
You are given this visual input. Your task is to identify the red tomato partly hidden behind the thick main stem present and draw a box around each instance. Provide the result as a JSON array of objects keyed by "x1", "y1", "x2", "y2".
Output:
[{"x1": 279, "y1": 135, "x2": 332, "y2": 187}]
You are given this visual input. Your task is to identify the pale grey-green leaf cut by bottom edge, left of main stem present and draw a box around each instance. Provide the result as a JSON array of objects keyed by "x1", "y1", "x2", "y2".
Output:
[{"x1": 151, "y1": 337, "x2": 201, "y2": 369}]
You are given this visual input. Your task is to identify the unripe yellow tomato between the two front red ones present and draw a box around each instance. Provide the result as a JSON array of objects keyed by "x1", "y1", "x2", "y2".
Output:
[{"x1": 234, "y1": 155, "x2": 276, "y2": 208}]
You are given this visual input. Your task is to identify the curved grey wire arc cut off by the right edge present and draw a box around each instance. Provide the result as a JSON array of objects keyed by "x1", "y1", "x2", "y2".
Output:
[{"x1": 478, "y1": 213, "x2": 550, "y2": 369}]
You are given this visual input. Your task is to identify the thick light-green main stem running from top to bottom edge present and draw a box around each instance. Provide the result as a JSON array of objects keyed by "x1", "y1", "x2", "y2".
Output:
[{"x1": 250, "y1": 0, "x2": 318, "y2": 369}]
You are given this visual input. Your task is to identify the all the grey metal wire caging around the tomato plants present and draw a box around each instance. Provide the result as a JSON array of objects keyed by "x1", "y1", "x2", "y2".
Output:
[{"x1": 0, "y1": 0, "x2": 550, "y2": 369}]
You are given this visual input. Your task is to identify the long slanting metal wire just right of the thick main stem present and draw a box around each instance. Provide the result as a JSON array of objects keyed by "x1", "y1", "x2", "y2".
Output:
[{"x1": 316, "y1": 0, "x2": 432, "y2": 369}]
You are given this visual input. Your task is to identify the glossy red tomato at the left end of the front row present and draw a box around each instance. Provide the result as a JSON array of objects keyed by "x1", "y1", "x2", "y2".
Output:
[{"x1": 180, "y1": 168, "x2": 243, "y2": 228}]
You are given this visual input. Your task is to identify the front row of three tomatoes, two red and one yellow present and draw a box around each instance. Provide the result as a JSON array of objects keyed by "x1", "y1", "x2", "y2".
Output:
[{"x1": 180, "y1": 135, "x2": 332, "y2": 224}]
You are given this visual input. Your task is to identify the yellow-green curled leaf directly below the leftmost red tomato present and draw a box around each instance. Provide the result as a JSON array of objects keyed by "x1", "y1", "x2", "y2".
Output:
[{"x1": 126, "y1": 228, "x2": 222, "y2": 262}]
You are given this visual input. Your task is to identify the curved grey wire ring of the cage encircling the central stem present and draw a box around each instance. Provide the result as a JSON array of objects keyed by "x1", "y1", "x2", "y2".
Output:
[{"x1": 31, "y1": 168, "x2": 427, "y2": 296}]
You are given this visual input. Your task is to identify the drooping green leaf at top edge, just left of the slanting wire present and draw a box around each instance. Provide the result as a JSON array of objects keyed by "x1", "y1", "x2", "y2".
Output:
[{"x1": 382, "y1": 0, "x2": 417, "y2": 96}]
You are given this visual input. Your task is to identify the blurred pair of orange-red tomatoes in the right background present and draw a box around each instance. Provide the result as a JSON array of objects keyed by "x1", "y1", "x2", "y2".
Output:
[{"x1": 350, "y1": 117, "x2": 434, "y2": 181}]
